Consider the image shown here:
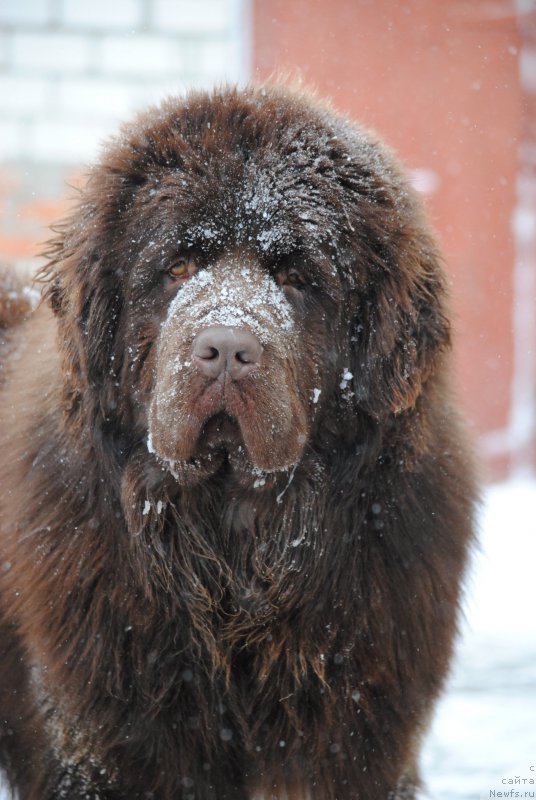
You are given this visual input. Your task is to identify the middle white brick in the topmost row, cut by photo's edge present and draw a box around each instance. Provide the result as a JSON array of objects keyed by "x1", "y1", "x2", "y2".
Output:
[{"x1": 61, "y1": 0, "x2": 143, "y2": 30}]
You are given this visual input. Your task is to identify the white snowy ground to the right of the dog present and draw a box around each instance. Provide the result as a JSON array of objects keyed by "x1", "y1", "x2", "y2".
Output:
[{"x1": 0, "y1": 481, "x2": 536, "y2": 800}]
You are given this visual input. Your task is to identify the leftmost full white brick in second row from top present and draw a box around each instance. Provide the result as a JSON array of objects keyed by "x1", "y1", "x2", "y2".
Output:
[{"x1": 12, "y1": 32, "x2": 92, "y2": 75}]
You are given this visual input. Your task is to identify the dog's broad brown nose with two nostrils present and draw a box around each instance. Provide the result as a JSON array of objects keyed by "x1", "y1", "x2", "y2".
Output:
[{"x1": 192, "y1": 325, "x2": 262, "y2": 381}]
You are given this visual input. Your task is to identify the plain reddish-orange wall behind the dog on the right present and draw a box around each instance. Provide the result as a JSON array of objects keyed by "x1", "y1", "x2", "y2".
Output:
[{"x1": 253, "y1": 0, "x2": 522, "y2": 476}]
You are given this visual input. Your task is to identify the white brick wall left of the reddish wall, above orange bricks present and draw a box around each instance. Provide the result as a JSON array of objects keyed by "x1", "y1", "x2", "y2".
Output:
[{"x1": 0, "y1": 0, "x2": 251, "y2": 164}]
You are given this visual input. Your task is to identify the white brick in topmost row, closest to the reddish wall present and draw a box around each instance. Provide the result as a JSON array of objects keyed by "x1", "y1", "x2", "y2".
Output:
[{"x1": 152, "y1": 0, "x2": 234, "y2": 34}]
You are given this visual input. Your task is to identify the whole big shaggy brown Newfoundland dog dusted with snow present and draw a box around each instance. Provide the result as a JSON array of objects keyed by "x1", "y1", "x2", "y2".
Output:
[{"x1": 0, "y1": 87, "x2": 474, "y2": 800}]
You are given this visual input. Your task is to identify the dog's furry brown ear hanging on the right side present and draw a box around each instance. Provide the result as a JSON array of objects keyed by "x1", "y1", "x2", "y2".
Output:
[{"x1": 350, "y1": 216, "x2": 450, "y2": 419}]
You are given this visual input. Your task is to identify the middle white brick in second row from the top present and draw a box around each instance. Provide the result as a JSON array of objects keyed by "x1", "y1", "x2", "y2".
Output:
[{"x1": 97, "y1": 36, "x2": 184, "y2": 78}]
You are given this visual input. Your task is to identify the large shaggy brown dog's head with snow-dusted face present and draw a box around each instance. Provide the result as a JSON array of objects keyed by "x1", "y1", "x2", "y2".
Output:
[{"x1": 44, "y1": 88, "x2": 449, "y2": 485}]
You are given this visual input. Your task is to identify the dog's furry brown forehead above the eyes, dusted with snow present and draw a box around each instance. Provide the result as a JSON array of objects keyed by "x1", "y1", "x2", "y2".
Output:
[{"x1": 124, "y1": 96, "x2": 368, "y2": 255}]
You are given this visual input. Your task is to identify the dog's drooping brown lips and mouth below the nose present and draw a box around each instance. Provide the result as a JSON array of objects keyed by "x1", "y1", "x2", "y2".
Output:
[{"x1": 148, "y1": 340, "x2": 309, "y2": 475}]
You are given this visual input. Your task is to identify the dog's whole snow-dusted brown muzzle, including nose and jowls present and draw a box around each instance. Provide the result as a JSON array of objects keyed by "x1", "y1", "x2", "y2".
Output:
[{"x1": 149, "y1": 255, "x2": 316, "y2": 482}]
